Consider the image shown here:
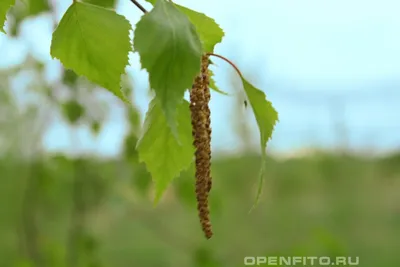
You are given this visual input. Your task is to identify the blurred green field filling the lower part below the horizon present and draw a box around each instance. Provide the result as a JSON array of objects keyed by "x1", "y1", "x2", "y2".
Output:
[{"x1": 0, "y1": 154, "x2": 400, "y2": 267}]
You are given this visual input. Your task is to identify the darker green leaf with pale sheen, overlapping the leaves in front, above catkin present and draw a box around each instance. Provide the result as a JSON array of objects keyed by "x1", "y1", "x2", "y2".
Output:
[{"x1": 133, "y1": 0, "x2": 202, "y2": 135}]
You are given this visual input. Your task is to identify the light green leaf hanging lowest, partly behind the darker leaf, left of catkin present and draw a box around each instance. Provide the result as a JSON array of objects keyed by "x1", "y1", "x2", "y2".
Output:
[{"x1": 137, "y1": 98, "x2": 194, "y2": 203}]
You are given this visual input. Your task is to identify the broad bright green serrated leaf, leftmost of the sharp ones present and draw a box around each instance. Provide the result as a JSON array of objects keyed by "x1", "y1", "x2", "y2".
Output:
[{"x1": 51, "y1": 2, "x2": 131, "y2": 101}]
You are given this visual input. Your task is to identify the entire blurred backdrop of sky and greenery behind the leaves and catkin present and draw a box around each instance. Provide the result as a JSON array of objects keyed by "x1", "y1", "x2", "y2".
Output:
[{"x1": 0, "y1": 0, "x2": 400, "y2": 267}]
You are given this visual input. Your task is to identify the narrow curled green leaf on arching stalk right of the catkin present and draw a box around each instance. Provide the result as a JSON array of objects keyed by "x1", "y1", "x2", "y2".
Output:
[{"x1": 241, "y1": 77, "x2": 278, "y2": 211}]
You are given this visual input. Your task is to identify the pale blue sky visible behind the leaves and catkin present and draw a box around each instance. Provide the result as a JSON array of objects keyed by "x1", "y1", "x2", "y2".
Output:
[{"x1": 0, "y1": 0, "x2": 400, "y2": 155}]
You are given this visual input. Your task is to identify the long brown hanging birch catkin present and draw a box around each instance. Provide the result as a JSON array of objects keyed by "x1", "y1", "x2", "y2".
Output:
[{"x1": 190, "y1": 56, "x2": 212, "y2": 238}]
